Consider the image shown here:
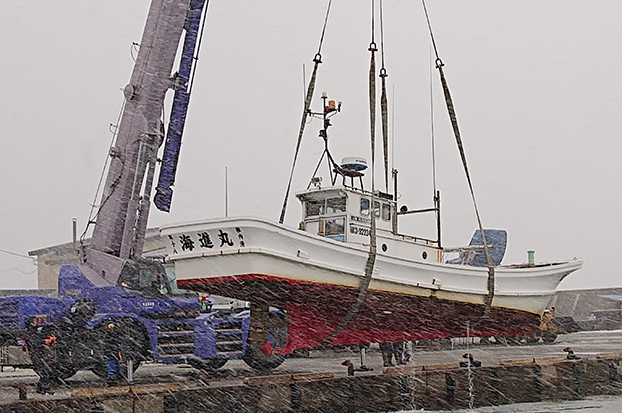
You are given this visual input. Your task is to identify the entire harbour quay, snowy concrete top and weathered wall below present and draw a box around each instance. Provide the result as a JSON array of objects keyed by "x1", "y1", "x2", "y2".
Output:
[{"x1": 0, "y1": 331, "x2": 622, "y2": 413}]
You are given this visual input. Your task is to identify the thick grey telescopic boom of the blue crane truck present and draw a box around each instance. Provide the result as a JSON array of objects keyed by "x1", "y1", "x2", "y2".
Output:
[{"x1": 92, "y1": 0, "x2": 206, "y2": 259}]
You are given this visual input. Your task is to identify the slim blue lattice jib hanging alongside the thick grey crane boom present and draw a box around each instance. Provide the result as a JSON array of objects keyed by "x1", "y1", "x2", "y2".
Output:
[{"x1": 153, "y1": 0, "x2": 209, "y2": 212}]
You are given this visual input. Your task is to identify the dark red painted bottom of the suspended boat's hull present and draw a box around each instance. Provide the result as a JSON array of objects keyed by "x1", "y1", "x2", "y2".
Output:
[{"x1": 178, "y1": 274, "x2": 540, "y2": 354}]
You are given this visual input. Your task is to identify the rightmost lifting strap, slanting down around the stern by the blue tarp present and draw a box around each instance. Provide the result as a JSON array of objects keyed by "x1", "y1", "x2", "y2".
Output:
[{"x1": 421, "y1": 0, "x2": 495, "y2": 318}]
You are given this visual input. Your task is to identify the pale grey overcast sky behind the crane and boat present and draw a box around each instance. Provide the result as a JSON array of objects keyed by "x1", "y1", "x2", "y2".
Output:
[{"x1": 0, "y1": 0, "x2": 622, "y2": 289}]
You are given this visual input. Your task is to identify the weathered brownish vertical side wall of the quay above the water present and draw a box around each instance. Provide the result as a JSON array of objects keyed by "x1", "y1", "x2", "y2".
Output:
[{"x1": 0, "y1": 354, "x2": 622, "y2": 413}]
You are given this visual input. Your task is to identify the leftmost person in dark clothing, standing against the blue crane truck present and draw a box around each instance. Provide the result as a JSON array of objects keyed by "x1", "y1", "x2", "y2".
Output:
[{"x1": 26, "y1": 320, "x2": 56, "y2": 394}]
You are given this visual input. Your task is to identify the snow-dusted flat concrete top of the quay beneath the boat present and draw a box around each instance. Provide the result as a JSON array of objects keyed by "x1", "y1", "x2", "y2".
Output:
[{"x1": 0, "y1": 330, "x2": 622, "y2": 411}]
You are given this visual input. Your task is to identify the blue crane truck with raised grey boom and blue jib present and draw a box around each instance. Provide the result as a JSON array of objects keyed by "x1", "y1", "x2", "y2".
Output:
[{"x1": 0, "y1": 0, "x2": 278, "y2": 379}]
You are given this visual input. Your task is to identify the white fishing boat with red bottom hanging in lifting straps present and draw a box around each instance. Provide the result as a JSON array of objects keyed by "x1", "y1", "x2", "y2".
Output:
[{"x1": 161, "y1": 3, "x2": 582, "y2": 355}]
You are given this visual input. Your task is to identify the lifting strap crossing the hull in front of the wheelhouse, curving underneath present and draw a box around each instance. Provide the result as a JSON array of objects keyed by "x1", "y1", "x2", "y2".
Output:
[{"x1": 326, "y1": 0, "x2": 378, "y2": 343}]
